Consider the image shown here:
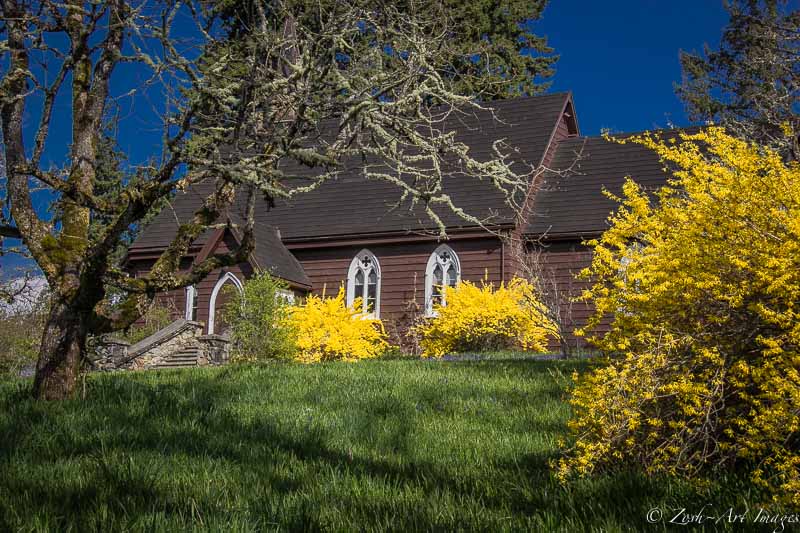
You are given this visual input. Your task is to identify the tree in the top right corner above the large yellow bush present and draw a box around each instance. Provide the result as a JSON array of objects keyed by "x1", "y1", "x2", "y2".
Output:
[{"x1": 677, "y1": 0, "x2": 800, "y2": 160}]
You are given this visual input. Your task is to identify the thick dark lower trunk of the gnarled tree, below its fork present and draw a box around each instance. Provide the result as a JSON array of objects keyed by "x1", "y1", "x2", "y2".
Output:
[{"x1": 33, "y1": 302, "x2": 87, "y2": 400}]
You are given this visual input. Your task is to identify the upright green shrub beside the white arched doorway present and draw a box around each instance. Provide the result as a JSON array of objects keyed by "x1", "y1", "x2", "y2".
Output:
[{"x1": 224, "y1": 272, "x2": 295, "y2": 362}]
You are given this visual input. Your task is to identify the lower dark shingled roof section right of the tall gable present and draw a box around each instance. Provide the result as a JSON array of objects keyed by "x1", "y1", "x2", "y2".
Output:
[{"x1": 526, "y1": 128, "x2": 698, "y2": 237}]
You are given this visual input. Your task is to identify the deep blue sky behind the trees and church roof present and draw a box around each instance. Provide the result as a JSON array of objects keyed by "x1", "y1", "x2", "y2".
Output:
[{"x1": 0, "y1": 0, "x2": 727, "y2": 277}]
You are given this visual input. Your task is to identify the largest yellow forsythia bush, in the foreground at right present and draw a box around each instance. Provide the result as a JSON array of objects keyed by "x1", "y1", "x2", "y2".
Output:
[{"x1": 558, "y1": 128, "x2": 800, "y2": 506}]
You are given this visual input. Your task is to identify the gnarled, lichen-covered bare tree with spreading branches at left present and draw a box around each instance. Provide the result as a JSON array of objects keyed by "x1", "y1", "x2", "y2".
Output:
[{"x1": 0, "y1": 0, "x2": 549, "y2": 398}]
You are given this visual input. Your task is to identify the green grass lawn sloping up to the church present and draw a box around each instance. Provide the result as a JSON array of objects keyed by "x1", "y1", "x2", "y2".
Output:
[{"x1": 0, "y1": 359, "x2": 772, "y2": 531}]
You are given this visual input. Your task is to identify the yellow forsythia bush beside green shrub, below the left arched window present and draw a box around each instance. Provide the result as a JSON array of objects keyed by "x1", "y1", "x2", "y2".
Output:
[{"x1": 285, "y1": 289, "x2": 389, "y2": 363}]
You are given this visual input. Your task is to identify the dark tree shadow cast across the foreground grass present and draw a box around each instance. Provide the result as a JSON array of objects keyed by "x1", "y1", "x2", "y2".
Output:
[{"x1": 0, "y1": 361, "x2": 776, "y2": 530}]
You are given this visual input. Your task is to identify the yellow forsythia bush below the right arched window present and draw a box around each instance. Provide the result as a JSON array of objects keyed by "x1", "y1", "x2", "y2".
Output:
[{"x1": 417, "y1": 278, "x2": 550, "y2": 357}]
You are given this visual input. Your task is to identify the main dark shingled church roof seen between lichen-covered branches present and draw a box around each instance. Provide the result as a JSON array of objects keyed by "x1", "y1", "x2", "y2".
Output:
[{"x1": 131, "y1": 93, "x2": 571, "y2": 256}]
